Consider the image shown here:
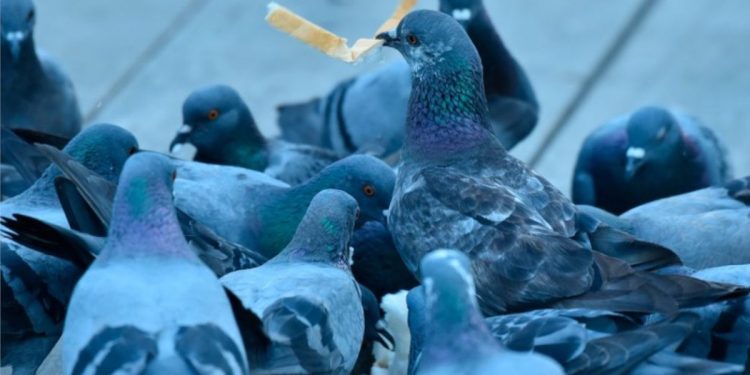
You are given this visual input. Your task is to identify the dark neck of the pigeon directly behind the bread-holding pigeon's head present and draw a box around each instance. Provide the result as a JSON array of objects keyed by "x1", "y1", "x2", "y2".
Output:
[{"x1": 466, "y1": 6, "x2": 535, "y2": 100}]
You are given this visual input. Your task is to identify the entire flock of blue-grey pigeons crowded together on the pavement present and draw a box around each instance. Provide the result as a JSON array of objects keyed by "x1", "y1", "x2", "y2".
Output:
[{"x1": 0, "y1": 0, "x2": 750, "y2": 374}]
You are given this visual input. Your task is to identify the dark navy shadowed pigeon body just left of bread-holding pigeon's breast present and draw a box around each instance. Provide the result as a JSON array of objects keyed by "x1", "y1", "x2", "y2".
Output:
[{"x1": 351, "y1": 221, "x2": 418, "y2": 301}]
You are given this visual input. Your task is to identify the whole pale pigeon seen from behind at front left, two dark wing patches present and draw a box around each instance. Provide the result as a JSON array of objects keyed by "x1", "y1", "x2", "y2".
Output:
[{"x1": 62, "y1": 153, "x2": 249, "y2": 374}]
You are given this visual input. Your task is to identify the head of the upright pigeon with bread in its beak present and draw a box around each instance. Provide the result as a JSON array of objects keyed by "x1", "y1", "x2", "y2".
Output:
[{"x1": 377, "y1": 10, "x2": 482, "y2": 77}]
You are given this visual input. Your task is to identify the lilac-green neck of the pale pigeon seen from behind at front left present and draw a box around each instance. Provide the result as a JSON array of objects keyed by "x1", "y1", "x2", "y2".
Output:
[{"x1": 102, "y1": 174, "x2": 192, "y2": 257}]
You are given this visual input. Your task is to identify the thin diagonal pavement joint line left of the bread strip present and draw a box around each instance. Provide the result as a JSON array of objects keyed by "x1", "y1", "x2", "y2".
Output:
[{"x1": 84, "y1": 0, "x2": 210, "y2": 124}]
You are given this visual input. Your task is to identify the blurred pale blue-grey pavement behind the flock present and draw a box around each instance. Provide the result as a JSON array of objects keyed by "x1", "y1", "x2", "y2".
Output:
[{"x1": 35, "y1": 0, "x2": 750, "y2": 193}]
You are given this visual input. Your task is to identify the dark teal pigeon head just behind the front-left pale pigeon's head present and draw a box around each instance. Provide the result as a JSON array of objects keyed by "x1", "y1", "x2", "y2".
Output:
[{"x1": 63, "y1": 124, "x2": 138, "y2": 182}]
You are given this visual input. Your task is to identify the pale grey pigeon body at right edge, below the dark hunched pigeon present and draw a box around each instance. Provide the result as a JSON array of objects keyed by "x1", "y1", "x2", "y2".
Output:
[{"x1": 579, "y1": 176, "x2": 750, "y2": 270}]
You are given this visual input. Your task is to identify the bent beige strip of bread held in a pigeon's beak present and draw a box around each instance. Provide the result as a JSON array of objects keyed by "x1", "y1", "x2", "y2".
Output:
[{"x1": 266, "y1": 0, "x2": 417, "y2": 63}]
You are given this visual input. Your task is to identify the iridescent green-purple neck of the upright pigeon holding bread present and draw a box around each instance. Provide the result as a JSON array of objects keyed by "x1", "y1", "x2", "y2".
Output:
[{"x1": 403, "y1": 63, "x2": 496, "y2": 159}]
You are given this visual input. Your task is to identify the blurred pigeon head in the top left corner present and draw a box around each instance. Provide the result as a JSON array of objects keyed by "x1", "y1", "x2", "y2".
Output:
[{"x1": 0, "y1": 0, "x2": 36, "y2": 64}]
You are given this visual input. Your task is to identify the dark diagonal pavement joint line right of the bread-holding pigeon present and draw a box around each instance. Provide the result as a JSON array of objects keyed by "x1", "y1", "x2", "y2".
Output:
[{"x1": 528, "y1": 0, "x2": 659, "y2": 168}]
